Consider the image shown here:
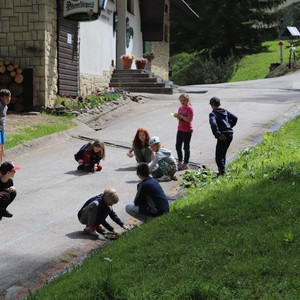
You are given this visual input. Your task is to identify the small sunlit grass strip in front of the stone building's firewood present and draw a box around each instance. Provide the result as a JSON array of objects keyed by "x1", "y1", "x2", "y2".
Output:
[{"x1": 5, "y1": 114, "x2": 75, "y2": 149}]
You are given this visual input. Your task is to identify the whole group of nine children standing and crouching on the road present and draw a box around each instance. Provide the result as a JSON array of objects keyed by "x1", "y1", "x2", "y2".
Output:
[{"x1": 0, "y1": 89, "x2": 237, "y2": 239}]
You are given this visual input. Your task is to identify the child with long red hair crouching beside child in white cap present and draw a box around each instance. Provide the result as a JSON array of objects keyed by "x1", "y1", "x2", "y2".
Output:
[{"x1": 127, "y1": 128, "x2": 152, "y2": 163}]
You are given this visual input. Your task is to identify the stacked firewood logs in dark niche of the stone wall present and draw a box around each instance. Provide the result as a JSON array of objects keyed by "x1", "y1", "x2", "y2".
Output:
[{"x1": 0, "y1": 60, "x2": 25, "y2": 112}]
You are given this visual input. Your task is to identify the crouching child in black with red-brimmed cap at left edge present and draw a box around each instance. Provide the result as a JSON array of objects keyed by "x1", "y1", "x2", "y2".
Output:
[{"x1": 0, "y1": 161, "x2": 20, "y2": 220}]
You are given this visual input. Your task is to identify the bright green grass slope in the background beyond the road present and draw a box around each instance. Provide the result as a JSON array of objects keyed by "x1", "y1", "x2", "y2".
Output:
[{"x1": 230, "y1": 41, "x2": 290, "y2": 82}]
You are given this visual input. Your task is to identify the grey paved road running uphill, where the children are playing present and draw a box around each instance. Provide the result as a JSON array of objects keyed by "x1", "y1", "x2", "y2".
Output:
[{"x1": 0, "y1": 73, "x2": 300, "y2": 299}]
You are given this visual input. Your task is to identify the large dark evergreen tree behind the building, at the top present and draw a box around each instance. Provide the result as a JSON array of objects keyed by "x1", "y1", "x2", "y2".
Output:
[{"x1": 171, "y1": 0, "x2": 286, "y2": 57}]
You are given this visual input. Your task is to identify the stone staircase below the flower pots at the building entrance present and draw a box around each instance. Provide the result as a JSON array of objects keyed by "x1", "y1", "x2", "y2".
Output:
[{"x1": 109, "y1": 69, "x2": 175, "y2": 94}]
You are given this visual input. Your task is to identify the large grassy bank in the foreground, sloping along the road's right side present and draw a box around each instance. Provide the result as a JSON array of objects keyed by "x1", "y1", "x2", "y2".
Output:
[{"x1": 28, "y1": 114, "x2": 300, "y2": 300}]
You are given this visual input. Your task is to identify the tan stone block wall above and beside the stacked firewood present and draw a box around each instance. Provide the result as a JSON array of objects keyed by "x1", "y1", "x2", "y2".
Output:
[{"x1": 0, "y1": 0, "x2": 58, "y2": 106}]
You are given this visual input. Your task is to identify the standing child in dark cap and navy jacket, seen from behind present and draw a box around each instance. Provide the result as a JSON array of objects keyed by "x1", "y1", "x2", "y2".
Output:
[{"x1": 209, "y1": 97, "x2": 238, "y2": 176}]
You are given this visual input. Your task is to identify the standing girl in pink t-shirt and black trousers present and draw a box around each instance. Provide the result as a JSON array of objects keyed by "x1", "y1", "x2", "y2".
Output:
[{"x1": 174, "y1": 94, "x2": 194, "y2": 171}]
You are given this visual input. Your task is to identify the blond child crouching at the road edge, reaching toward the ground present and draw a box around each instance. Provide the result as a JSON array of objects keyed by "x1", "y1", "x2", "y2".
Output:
[{"x1": 77, "y1": 189, "x2": 129, "y2": 240}]
